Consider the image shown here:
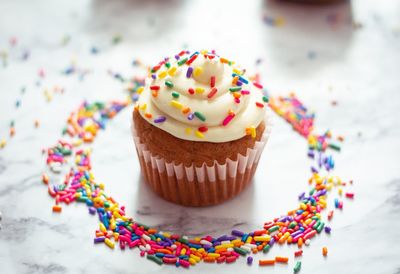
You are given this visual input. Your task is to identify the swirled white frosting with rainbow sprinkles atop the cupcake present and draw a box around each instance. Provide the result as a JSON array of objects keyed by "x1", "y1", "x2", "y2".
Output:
[{"x1": 137, "y1": 52, "x2": 268, "y2": 143}]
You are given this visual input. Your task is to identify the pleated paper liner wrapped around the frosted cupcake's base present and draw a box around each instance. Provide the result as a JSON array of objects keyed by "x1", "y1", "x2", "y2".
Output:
[{"x1": 132, "y1": 111, "x2": 271, "y2": 206}]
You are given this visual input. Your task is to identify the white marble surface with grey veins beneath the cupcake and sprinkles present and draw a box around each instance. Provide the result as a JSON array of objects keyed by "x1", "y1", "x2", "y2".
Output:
[{"x1": 0, "y1": 0, "x2": 400, "y2": 274}]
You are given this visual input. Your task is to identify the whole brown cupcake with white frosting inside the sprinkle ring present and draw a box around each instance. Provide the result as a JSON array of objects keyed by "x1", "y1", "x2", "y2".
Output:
[{"x1": 132, "y1": 51, "x2": 271, "y2": 206}]
